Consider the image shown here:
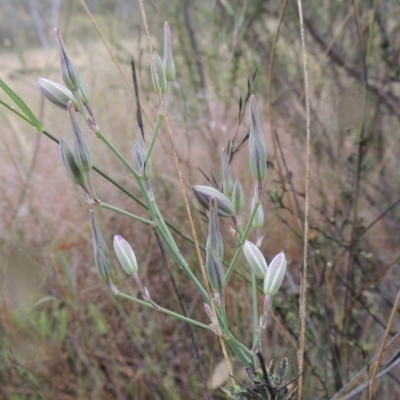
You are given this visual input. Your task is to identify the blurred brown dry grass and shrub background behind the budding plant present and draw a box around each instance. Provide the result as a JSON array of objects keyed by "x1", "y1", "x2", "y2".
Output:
[{"x1": 0, "y1": 0, "x2": 400, "y2": 400}]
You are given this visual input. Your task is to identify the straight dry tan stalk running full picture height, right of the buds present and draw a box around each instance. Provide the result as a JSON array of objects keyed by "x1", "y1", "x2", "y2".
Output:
[{"x1": 297, "y1": 0, "x2": 311, "y2": 400}]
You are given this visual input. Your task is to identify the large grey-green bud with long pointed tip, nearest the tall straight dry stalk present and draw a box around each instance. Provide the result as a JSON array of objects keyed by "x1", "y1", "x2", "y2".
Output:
[{"x1": 249, "y1": 95, "x2": 267, "y2": 181}]
